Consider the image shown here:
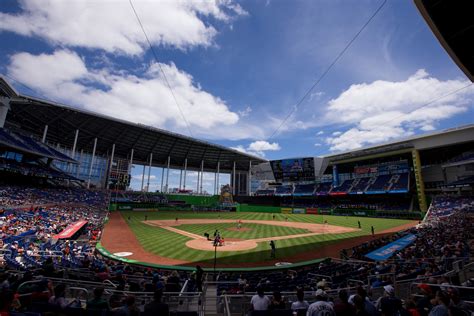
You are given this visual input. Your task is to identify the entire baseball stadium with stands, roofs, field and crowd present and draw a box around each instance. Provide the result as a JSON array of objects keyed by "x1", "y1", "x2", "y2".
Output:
[{"x1": 0, "y1": 0, "x2": 474, "y2": 316}]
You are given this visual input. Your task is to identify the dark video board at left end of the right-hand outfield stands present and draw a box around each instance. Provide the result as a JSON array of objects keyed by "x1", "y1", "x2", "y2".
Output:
[{"x1": 270, "y1": 157, "x2": 315, "y2": 182}]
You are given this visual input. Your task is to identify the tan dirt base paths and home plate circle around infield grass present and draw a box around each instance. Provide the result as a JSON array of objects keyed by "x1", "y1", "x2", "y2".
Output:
[{"x1": 142, "y1": 219, "x2": 358, "y2": 251}]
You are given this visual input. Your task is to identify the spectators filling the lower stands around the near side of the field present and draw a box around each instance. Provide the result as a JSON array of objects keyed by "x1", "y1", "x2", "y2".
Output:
[{"x1": 0, "y1": 186, "x2": 474, "y2": 316}]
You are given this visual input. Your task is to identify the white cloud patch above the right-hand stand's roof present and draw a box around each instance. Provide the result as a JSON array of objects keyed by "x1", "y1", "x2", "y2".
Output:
[{"x1": 325, "y1": 69, "x2": 474, "y2": 151}]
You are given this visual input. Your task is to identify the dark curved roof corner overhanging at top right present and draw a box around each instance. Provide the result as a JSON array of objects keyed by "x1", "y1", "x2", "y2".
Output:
[{"x1": 414, "y1": 0, "x2": 474, "y2": 82}]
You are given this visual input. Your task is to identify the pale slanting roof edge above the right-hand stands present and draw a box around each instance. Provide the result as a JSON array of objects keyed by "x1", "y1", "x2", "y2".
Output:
[{"x1": 325, "y1": 124, "x2": 474, "y2": 163}]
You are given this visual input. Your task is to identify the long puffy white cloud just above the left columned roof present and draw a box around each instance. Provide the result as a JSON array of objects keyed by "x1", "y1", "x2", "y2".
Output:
[{"x1": 8, "y1": 50, "x2": 241, "y2": 132}]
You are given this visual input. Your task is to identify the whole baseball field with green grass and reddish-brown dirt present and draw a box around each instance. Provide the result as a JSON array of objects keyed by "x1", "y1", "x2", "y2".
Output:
[{"x1": 101, "y1": 211, "x2": 417, "y2": 268}]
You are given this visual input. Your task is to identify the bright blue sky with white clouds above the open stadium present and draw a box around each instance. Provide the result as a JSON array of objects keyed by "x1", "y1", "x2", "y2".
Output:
[{"x1": 0, "y1": 0, "x2": 474, "y2": 190}]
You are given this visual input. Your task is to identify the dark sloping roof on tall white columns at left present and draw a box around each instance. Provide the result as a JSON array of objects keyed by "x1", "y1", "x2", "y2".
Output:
[{"x1": 0, "y1": 77, "x2": 266, "y2": 171}]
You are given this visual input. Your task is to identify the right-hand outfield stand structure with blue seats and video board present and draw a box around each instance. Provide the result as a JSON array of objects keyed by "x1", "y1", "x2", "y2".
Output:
[{"x1": 250, "y1": 125, "x2": 474, "y2": 212}]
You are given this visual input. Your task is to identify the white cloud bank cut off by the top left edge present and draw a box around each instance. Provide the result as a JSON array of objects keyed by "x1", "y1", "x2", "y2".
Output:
[{"x1": 0, "y1": 0, "x2": 247, "y2": 55}]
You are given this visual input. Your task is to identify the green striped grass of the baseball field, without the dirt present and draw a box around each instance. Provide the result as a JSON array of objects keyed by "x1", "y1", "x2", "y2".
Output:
[{"x1": 117, "y1": 211, "x2": 409, "y2": 266}]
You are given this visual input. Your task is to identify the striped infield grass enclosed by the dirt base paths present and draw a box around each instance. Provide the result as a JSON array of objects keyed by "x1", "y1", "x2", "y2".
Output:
[{"x1": 176, "y1": 223, "x2": 310, "y2": 239}]
